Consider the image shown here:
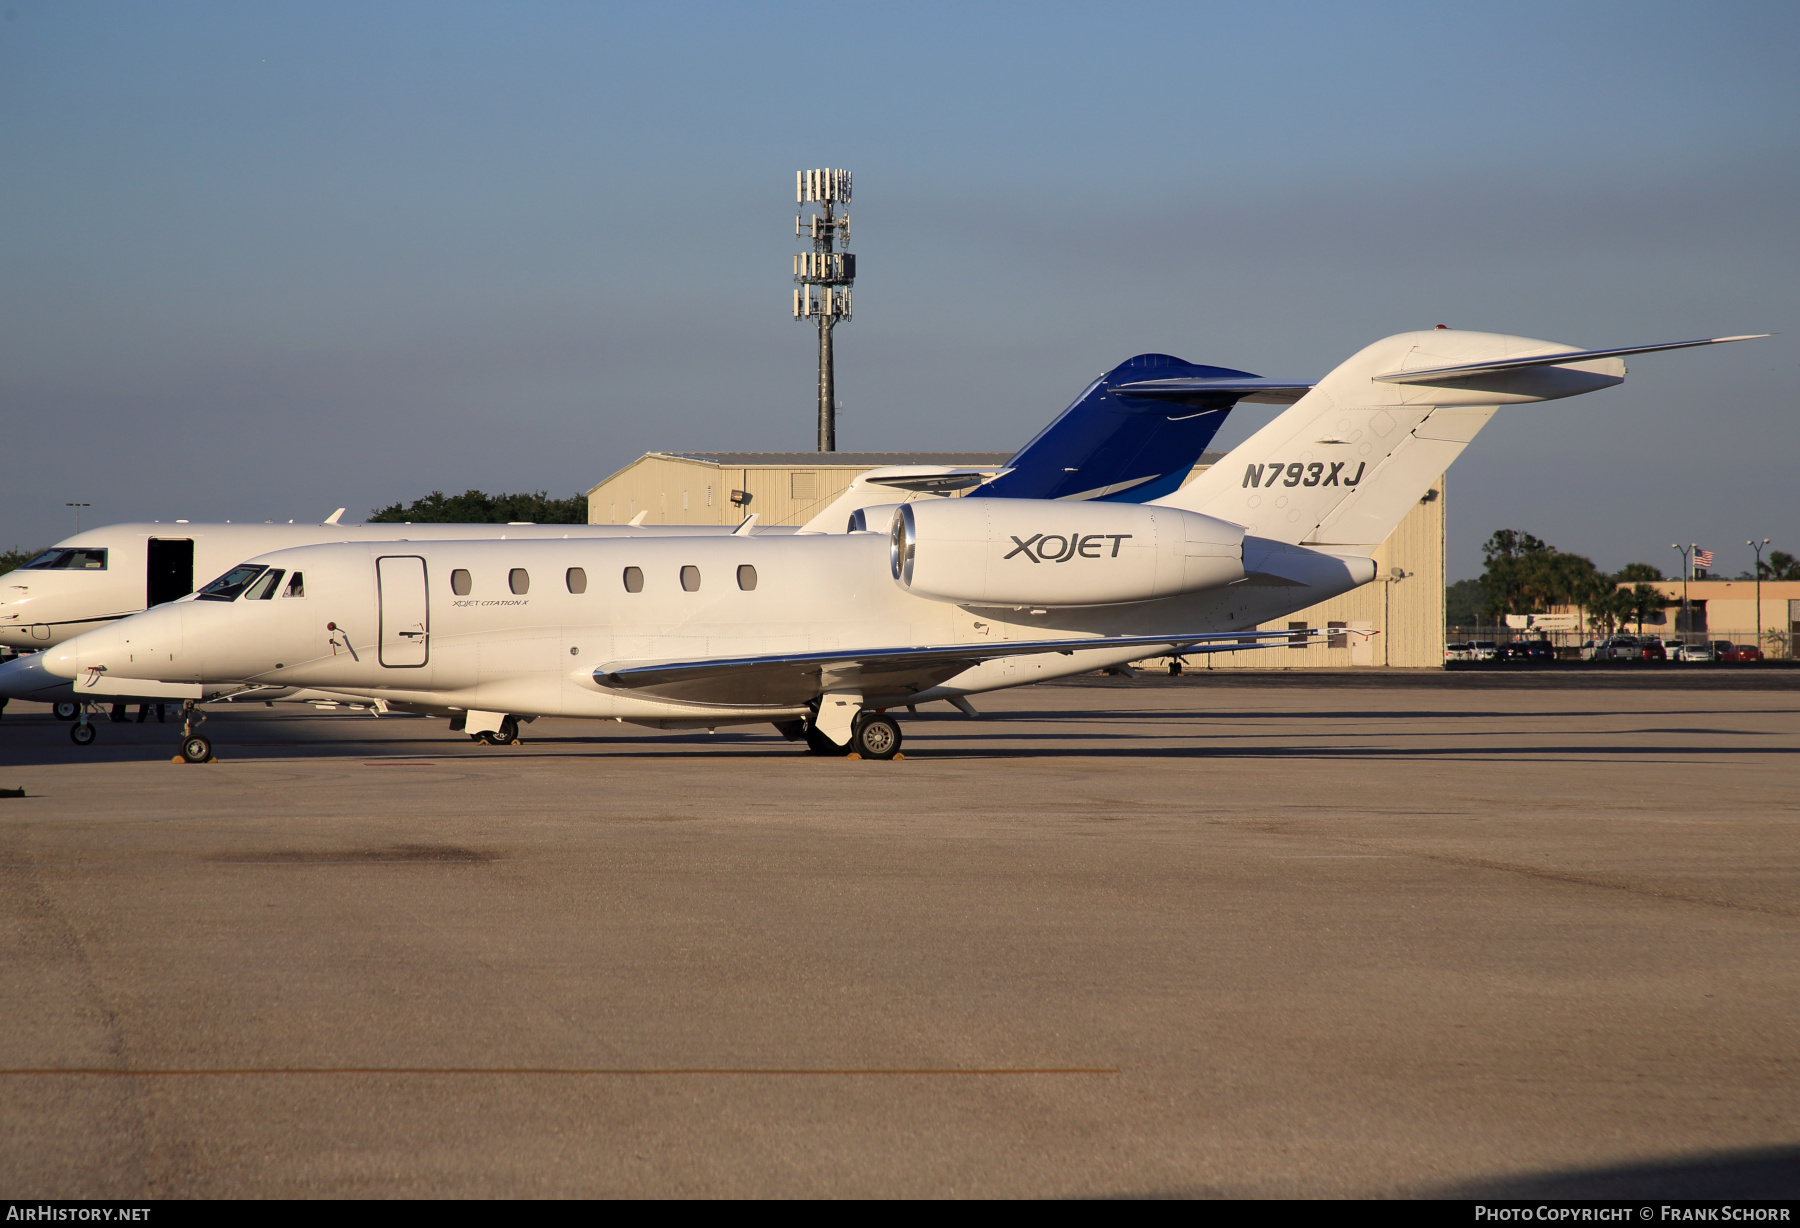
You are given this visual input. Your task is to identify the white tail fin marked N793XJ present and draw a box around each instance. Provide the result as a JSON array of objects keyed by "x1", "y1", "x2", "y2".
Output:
[{"x1": 1156, "y1": 330, "x2": 1713, "y2": 555}]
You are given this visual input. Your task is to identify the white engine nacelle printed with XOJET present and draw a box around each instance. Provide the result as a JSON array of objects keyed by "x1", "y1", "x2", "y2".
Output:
[{"x1": 889, "y1": 499, "x2": 1244, "y2": 609}]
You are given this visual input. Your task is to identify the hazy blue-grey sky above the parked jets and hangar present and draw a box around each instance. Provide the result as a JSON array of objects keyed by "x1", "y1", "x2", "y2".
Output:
[{"x1": 0, "y1": 0, "x2": 1800, "y2": 578}]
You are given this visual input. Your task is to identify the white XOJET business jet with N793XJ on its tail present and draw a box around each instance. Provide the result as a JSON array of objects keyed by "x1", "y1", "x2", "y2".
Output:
[{"x1": 43, "y1": 330, "x2": 1746, "y2": 762}]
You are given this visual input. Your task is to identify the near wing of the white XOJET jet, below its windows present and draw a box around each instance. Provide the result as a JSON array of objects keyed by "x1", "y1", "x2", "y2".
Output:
[{"x1": 594, "y1": 628, "x2": 1341, "y2": 708}]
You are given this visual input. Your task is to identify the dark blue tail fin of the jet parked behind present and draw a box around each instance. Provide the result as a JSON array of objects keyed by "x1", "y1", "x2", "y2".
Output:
[{"x1": 968, "y1": 355, "x2": 1296, "y2": 502}]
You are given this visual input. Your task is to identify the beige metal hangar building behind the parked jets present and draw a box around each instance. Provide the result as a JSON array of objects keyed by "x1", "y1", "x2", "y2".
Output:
[{"x1": 587, "y1": 452, "x2": 1444, "y2": 670}]
